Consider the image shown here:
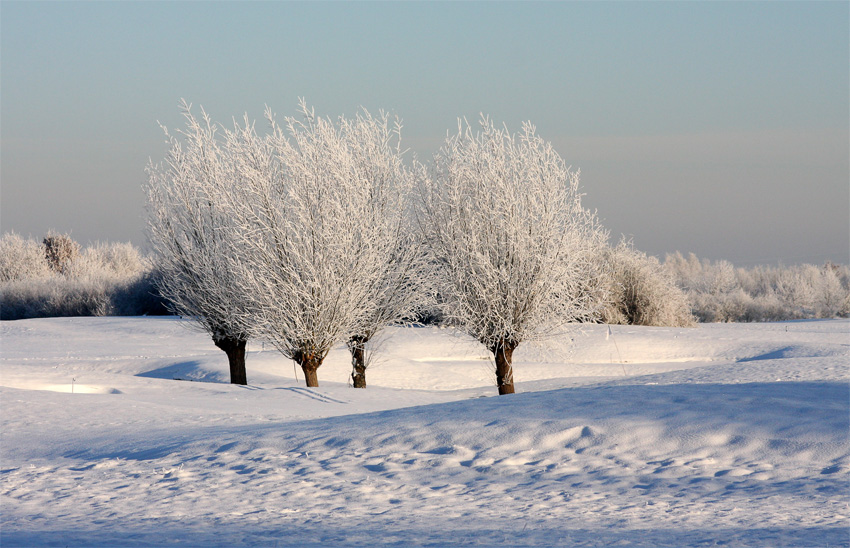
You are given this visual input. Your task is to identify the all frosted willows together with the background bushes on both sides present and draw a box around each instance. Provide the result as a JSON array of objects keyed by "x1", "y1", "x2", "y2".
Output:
[{"x1": 11, "y1": 101, "x2": 850, "y2": 394}]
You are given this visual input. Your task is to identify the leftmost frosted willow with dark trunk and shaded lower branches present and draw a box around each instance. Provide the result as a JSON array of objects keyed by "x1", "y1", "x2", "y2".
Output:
[{"x1": 145, "y1": 102, "x2": 248, "y2": 384}]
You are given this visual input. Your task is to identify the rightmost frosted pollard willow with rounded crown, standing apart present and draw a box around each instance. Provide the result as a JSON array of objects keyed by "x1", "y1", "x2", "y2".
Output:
[{"x1": 417, "y1": 118, "x2": 607, "y2": 394}]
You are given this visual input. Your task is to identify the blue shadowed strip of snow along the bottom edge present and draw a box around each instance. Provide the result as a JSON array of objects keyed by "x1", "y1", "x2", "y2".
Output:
[{"x1": 0, "y1": 517, "x2": 850, "y2": 548}]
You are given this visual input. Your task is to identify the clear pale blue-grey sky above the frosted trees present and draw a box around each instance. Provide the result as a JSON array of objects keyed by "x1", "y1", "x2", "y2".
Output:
[{"x1": 0, "y1": 0, "x2": 850, "y2": 266}]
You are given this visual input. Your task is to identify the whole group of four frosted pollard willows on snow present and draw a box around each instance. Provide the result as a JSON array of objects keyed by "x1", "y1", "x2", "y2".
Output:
[{"x1": 147, "y1": 101, "x2": 607, "y2": 394}]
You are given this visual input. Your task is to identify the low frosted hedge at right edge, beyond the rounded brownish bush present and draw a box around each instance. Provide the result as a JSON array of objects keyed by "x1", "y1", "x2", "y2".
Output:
[{"x1": 664, "y1": 252, "x2": 850, "y2": 322}]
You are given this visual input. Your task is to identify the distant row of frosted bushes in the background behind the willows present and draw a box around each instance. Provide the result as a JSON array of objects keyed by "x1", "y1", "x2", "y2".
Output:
[{"x1": 0, "y1": 233, "x2": 850, "y2": 326}]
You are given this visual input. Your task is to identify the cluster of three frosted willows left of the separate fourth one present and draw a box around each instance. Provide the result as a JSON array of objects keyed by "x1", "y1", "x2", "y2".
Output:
[{"x1": 147, "y1": 102, "x2": 428, "y2": 387}]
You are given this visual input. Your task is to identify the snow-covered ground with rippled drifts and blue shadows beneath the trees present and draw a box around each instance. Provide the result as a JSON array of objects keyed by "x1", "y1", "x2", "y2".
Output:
[{"x1": 0, "y1": 318, "x2": 850, "y2": 548}]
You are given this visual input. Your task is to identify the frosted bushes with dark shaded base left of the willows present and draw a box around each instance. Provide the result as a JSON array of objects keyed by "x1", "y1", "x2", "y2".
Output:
[{"x1": 0, "y1": 233, "x2": 166, "y2": 320}]
